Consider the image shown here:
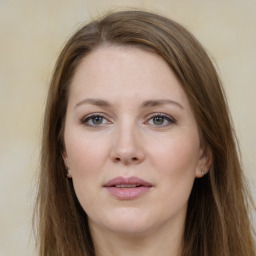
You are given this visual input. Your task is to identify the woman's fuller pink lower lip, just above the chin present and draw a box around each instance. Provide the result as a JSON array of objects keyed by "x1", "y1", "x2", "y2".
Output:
[{"x1": 106, "y1": 186, "x2": 151, "y2": 200}]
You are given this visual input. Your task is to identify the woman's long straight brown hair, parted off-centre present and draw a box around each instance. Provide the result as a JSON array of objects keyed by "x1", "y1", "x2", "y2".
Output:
[{"x1": 35, "y1": 11, "x2": 256, "y2": 256}]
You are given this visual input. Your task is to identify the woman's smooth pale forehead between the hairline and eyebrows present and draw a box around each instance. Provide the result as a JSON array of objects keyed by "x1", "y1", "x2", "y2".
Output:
[{"x1": 70, "y1": 46, "x2": 187, "y2": 106}]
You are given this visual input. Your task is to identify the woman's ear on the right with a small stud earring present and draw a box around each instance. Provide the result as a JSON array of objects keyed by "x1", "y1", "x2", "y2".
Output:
[{"x1": 195, "y1": 143, "x2": 213, "y2": 178}]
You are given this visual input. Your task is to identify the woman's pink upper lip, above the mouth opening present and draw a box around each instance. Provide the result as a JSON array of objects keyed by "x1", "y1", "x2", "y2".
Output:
[{"x1": 104, "y1": 176, "x2": 153, "y2": 187}]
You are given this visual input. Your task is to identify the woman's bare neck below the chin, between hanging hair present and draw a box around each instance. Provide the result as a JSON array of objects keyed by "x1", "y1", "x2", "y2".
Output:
[{"x1": 91, "y1": 218, "x2": 183, "y2": 256}]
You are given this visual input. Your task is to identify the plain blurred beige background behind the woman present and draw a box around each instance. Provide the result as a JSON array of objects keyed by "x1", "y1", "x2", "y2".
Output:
[{"x1": 0, "y1": 0, "x2": 256, "y2": 256}]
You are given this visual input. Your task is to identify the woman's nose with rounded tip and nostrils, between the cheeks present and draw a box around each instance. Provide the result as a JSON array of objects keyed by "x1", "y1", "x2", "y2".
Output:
[{"x1": 110, "y1": 123, "x2": 145, "y2": 165}]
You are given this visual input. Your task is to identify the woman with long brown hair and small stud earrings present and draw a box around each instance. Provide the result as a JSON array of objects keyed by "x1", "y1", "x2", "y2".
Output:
[{"x1": 34, "y1": 11, "x2": 255, "y2": 256}]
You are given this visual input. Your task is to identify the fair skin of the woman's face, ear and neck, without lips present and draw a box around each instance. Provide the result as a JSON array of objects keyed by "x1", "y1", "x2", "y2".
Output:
[{"x1": 63, "y1": 46, "x2": 211, "y2": 256}]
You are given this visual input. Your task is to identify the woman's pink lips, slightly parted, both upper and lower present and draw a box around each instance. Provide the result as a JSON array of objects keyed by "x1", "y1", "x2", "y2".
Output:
[{"x1": 104, "y1": 177, "x2": 153, "y2": 200}]
